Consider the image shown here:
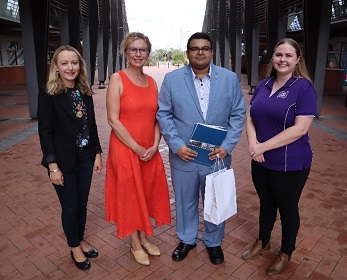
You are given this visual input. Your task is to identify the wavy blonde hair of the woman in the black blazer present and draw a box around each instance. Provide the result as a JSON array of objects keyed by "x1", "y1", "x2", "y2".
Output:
[{"x1": 46, "y1": 45, "x2": 92, "y2": 95}]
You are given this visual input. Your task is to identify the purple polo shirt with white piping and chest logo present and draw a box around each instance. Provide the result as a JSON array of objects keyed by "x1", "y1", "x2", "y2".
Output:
[{"x1": 250, "y1": 77, "x2": 317, "y2": 171}]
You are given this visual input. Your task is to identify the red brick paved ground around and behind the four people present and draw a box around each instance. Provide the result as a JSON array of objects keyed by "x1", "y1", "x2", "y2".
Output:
[{"x1": 0, "y1": 66, "x2": 347, "y2": 280}]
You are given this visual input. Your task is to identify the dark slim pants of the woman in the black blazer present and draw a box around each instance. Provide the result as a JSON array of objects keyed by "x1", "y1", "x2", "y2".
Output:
[{"x1": 53, "y1": 150, "x2": 94, "y2": 247}]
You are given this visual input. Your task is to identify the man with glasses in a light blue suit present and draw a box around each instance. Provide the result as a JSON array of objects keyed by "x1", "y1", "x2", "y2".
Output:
[{"x1": 157, "y1": 32, "x2": 245, "y2": 264}]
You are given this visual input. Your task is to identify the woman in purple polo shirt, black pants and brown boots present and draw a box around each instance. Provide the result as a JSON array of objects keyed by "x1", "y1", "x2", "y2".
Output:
[{"x1": 242, "y1": 38, "x2": 317, "y2": 275}]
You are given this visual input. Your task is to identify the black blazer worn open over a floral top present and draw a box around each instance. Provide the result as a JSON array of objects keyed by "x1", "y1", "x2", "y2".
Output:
[{"x1": 37, "y1": 87, "x2": 102, "y2": 172}]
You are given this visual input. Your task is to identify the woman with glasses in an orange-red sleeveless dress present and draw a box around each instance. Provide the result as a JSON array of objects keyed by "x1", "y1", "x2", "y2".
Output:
[{"x1": 105, "y1": 32, "x2": 171, "y2": 265}]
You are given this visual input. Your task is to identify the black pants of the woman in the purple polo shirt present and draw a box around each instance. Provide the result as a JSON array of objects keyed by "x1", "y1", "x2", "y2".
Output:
[{"x1": 252, "y1": 161, "x2": 310, "y2": 255}]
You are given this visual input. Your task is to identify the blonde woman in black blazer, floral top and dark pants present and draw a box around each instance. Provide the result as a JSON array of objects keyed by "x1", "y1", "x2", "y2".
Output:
[{"x1": 37, "y1": 46, "x2": 102, "y2": 269}]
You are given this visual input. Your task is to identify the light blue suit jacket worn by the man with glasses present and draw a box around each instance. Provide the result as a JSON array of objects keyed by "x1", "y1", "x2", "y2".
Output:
[{"x1": 157, "y1": 64, "x2": 245, "y2": 171}]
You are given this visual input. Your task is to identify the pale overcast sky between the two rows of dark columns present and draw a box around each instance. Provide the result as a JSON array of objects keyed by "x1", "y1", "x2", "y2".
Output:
[{"x1": 125, "y1": 0, "x2": 206, "y2": 51}]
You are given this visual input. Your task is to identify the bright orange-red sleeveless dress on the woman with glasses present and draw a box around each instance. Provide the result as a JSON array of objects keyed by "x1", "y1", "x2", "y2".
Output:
[{"x1": 105, "y1": 71, "x2": 171, "y2": 238}]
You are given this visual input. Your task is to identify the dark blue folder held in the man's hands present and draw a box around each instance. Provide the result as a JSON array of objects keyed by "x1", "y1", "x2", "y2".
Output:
[{"x1": 187, "y1": 123, "x2": 228, "y2": 166}]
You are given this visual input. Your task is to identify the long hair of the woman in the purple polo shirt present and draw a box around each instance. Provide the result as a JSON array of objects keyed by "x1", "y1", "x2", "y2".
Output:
[{"x1": 266, "y1": 38, "x2": 312, "y2": 83}]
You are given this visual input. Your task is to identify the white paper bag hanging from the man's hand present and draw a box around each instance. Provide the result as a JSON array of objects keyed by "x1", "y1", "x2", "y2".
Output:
[{"x1": 204, "y1": 168, "x2": 237, "y2": 225}]
